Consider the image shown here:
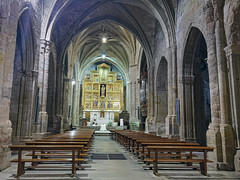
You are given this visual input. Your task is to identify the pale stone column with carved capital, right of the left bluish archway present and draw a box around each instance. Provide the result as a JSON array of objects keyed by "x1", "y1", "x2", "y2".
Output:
[{"x1": 34, "y1": 39, "x2": 50, "y2": 138}]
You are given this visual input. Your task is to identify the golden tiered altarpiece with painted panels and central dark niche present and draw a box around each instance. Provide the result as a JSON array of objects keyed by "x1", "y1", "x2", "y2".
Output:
[{"x1": 82, "y1": 63, "x2": 123, "y2": 125}]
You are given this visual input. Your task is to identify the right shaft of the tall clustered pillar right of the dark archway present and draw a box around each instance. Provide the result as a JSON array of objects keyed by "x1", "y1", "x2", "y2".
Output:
[{"x1": 213, "y1": 0, "x2": 234, "y2": 170}]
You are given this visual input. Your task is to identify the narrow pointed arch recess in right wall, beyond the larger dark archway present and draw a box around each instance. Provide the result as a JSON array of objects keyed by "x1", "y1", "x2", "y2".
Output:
[{"x1": 155, "y1": 57, "x2": 168, "y2": 135}]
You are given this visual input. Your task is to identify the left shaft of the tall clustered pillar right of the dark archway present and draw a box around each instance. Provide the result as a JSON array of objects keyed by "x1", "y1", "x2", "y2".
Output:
[{"x1": 204, "y1": 1, "x2": 222, "y2": 166}]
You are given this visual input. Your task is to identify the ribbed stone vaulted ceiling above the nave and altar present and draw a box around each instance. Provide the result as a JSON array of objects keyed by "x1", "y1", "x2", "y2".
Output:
[{"x1": 46, "y1": 0, "x2": 176, "y2": 81}]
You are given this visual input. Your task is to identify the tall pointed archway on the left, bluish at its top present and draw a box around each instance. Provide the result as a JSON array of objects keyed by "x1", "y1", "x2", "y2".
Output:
[{"x1": 10, "y1": 9, "x2": 37, "y2": 144}]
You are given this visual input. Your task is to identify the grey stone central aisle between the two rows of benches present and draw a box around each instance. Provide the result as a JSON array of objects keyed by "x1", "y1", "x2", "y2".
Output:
[{"x1": 84, "y1": 136, "x2": 159, "y2": 180}]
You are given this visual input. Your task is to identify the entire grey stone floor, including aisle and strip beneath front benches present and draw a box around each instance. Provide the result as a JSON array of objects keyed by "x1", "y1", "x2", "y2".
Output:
[{"x1": 0, "y1": 136, "x2": 240, "y2": 180}]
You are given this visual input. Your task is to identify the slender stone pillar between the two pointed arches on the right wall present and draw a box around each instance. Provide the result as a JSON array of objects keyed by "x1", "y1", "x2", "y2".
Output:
[{"x1": 166, "y1": 45, "x2": 179, "y2": 137}]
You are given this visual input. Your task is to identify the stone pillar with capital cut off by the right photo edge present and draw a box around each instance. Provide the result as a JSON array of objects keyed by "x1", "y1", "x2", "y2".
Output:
[{"x1": 224, "y1": 45, "x2": 240, "y2": 171}]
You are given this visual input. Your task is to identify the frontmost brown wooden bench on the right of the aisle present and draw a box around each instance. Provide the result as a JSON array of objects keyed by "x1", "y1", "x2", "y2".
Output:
[{"x1": 147, "y1": 145, "x2": 214, "y2": 175}]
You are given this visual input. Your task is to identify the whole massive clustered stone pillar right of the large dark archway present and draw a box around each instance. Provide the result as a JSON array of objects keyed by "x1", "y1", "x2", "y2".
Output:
[{"x1": 204, "y1": 0, "x2": 233, "y2": 170}]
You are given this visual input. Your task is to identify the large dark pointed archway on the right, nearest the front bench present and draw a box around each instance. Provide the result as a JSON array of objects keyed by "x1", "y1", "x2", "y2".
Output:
[{"x1": 181, "y1": 28, "x2": 211, "y2": 145}]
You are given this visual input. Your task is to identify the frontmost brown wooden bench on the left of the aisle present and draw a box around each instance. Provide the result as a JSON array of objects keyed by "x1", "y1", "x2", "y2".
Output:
[{"x1": 10, "y1": 145, "x2": 84, "y2": 177}]
